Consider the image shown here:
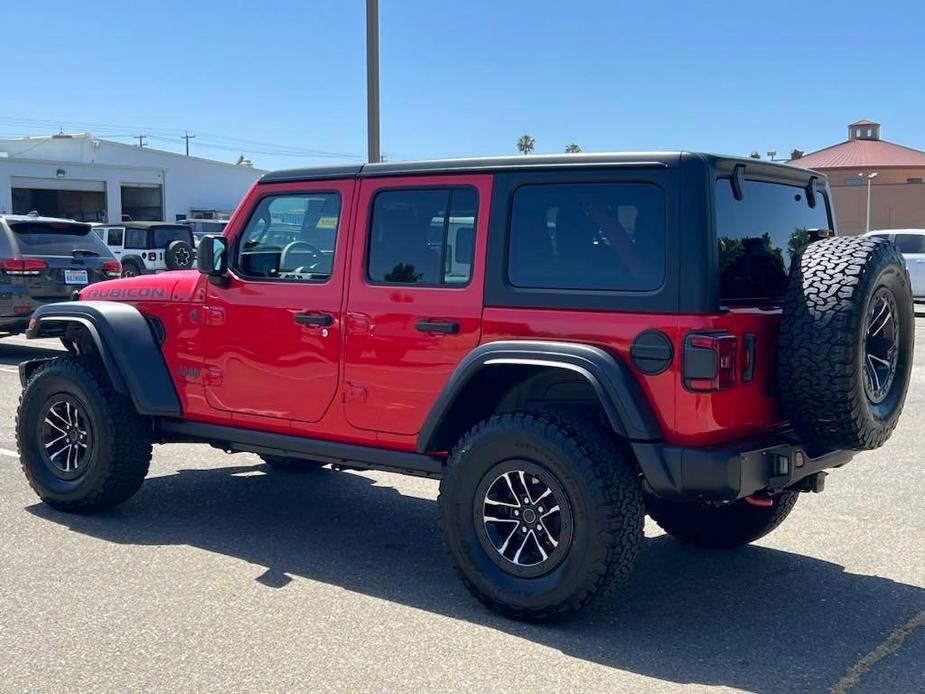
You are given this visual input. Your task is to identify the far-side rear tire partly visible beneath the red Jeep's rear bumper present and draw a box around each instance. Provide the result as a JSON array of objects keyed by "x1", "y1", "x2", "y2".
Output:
[{"x1": 648, "y1": 492, "x2": 800, "y2": 549}]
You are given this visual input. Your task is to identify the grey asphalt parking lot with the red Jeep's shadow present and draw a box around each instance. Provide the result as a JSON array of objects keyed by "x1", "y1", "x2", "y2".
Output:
[{"x1": 0, "y1": 328, "x2": 925, "y2": 693}]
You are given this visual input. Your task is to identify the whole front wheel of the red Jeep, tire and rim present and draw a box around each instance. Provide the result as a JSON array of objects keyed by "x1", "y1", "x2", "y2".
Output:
[{"x1": 16, "y1": 355, "x2": 151, "y2": 513}]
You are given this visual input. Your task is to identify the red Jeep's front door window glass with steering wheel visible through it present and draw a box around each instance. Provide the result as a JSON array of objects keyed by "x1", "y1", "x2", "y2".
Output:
[{"x1": 234, "y1": 192, "x2": 340, "y2": 282}]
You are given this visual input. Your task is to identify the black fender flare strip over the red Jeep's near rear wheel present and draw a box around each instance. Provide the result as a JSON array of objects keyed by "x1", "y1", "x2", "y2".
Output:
[{"x1": 417, "y1": 340, "x2": 662, "y2": 453}]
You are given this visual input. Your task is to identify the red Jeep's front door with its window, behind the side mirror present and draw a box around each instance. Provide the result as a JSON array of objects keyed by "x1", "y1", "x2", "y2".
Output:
[{"x1": 203, "y1": 180, "x2": 355, "y2": 422}]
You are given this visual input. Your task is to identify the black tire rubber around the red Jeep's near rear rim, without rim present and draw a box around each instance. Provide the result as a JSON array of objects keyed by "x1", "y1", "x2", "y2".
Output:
[{"x1": 438, "y1": 412, "x2": 643, "y2": 621}]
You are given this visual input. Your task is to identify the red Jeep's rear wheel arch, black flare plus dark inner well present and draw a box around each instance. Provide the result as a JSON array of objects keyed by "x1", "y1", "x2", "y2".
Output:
[{"x1": 417, "y1": 340, "x2": 662, "y2": 453}]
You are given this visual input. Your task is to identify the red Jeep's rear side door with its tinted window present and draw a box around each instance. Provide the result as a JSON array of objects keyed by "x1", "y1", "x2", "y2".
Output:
[{"x1": 344, "y1": 175, "x2": 491, "y2": 435}]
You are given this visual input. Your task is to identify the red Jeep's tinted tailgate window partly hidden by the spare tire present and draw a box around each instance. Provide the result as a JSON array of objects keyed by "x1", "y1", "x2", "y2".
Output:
[{"x1": 715, "y1": 178, "x2": 831, "y2": 303}]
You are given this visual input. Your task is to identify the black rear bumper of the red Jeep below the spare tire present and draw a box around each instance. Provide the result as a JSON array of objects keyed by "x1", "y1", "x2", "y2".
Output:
[{"x1": 633, "y1": 432, "x2": 855, "y2": 501}]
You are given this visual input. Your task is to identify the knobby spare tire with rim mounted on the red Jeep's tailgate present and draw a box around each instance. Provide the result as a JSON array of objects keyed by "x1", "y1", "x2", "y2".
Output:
[{"x1": 777, "y1": 236, "x2": 915, "y2": 450}]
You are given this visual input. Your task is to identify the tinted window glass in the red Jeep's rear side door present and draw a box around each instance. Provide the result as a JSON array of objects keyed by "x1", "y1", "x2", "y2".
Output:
[{"x1": 366, "y1": 188, "x2": 478, "y2": 286}]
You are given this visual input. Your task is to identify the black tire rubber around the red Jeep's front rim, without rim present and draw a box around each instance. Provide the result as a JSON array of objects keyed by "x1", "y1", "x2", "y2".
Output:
[{"x1": 16, "y1": 355, "x2": 152, "y2": 513}]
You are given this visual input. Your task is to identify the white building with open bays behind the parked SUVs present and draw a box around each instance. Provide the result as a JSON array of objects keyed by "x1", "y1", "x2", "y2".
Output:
[{"x1": 0, "y1": 133, "x2": 265, "y2": 222}]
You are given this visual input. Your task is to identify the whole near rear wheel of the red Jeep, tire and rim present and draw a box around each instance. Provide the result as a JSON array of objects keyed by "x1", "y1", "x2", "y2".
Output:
[{"x1": 439, "y1": 412, "x2": 643, "y2": 621}]
